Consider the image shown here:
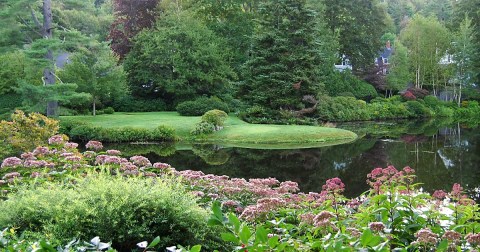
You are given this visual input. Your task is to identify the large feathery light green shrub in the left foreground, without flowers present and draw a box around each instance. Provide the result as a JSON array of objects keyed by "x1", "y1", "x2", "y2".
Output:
[{"x1": 0, "y1": 174, "x2": 208, "y2": 251}]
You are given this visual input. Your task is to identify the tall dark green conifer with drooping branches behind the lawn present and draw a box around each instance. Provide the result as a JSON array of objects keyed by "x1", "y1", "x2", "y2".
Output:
[{"x1": 240, "y1": 0, "x2": 334, "y2": 110}]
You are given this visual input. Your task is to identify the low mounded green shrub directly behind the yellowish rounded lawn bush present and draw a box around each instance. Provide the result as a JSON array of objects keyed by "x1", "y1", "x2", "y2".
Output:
[{"x1": 177, "y1": 97, "x2": 230, "y2": 116}]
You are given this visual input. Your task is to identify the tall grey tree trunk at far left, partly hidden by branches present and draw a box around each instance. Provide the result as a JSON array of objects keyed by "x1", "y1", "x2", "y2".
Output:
[{"x1": 42, "y1": 0, "x2": 58, "y2": 117}]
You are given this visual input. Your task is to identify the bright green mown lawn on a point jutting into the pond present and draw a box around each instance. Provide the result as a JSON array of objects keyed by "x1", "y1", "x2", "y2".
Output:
[{"x1": 61, "y1": 112, "x2": 357, "y2": 148}]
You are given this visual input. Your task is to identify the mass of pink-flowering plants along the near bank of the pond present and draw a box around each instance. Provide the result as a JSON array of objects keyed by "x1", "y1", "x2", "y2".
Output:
[{"x1": 0, "y1": 137, "x2": 480, "y2": 251}]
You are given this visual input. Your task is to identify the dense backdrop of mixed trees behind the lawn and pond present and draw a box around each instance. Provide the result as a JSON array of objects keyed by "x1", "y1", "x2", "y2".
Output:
[{"x1": 0, "y1": 0, "x2": 480, "y2": 124}]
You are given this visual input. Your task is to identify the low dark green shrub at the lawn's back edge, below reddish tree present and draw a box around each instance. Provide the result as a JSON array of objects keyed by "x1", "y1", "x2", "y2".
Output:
[{"x1": 113, "y1": 96, "x2": 167, "y2": 112}]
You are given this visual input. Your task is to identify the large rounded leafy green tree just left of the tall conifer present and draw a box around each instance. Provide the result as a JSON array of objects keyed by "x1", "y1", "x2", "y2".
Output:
[{"x1": 125, "y1": 12, "x2": 234, "y2": 104}]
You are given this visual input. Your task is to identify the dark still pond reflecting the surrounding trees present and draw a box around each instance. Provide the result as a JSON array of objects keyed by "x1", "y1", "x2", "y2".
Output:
[{"x1": 106, "y1": 120, "x2": 480, "y2": 201}]
